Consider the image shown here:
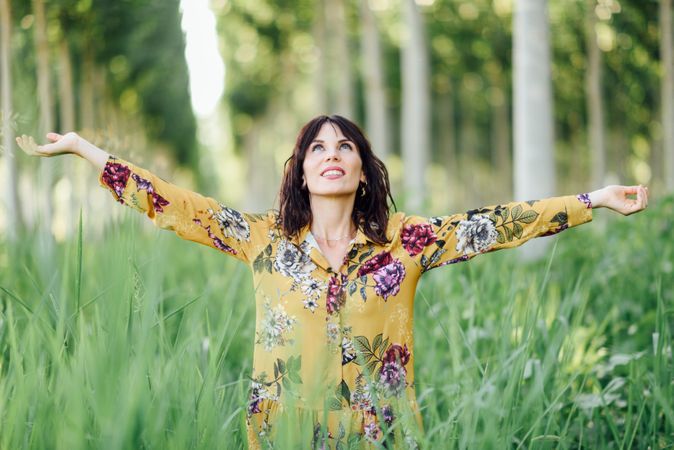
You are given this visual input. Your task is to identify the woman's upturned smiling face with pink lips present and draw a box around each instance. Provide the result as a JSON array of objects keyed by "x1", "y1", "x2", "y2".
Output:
[{"x1": 302, "y1": 123, "x2": 365, "y2": 197}]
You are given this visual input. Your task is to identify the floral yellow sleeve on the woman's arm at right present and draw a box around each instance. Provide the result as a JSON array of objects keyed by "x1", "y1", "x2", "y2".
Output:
[{"x1": 401, "y1": 194, "x2": 592, "y2": 272}]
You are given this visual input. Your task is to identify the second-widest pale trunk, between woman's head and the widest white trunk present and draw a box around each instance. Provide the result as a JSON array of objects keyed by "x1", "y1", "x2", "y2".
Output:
[{"x1": 400, "y1": 0, "x2": 430, "y2": 213}]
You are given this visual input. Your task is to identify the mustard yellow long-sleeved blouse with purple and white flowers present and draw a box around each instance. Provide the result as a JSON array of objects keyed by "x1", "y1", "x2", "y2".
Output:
[{"x1": 100, "y1": 156, "x2": 592, "y2": 448}]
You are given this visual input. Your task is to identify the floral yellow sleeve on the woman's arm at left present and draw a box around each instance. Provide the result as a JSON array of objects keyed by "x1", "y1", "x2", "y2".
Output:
[{"x1": 99, "y1": 156, "x2": 270, "y2": 263}]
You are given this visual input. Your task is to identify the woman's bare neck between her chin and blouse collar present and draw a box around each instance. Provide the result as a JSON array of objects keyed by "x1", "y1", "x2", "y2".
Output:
[{"x1": 309, "y1": 194, "x2": 356, "y2": 241}]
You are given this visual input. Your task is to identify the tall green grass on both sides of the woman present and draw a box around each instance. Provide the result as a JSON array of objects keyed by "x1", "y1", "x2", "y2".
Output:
[{"x1": 0, "y1": 198, "x2": 674, "y2": 450}]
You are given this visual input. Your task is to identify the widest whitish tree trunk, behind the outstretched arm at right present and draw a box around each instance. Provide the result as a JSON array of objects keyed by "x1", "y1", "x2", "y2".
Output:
[{"x1": 513, "y1": 0, "x2": 555, "y2": 259}]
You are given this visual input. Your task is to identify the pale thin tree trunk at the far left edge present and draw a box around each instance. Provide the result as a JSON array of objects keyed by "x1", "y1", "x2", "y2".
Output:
[{"x1": 0, "y1": 0, "x2": 22, "y2": 241}]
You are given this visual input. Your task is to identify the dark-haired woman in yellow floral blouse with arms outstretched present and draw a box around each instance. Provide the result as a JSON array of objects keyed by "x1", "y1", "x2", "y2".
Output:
[{"x1": 18, "y1": 116, "x2": 648, "y2": 448}]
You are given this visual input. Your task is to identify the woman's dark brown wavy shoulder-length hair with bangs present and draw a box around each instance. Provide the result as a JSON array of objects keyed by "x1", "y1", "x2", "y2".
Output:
[{"x1": 279, "y1": 115, "x2": 396, "y2": 244}]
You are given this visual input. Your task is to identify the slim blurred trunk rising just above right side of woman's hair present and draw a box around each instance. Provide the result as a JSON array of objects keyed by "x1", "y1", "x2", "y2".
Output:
[{"x1": 360, "y1": 1, "x2": 390, "y2": 160}]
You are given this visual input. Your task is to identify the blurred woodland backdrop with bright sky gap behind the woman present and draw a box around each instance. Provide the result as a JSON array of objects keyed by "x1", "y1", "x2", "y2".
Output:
[{"x1": 0, "y1": 0, "x2": 674, "y2": 240}]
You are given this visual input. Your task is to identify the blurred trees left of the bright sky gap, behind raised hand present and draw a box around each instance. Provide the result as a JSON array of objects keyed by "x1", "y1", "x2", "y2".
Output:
[{"x1": 0, "y1": 0, "x2": 196, "y2": 241}]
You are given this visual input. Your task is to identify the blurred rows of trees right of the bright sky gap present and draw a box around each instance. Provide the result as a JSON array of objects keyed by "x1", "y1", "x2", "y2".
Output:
[{"x1": 216, "y1": 0, "x2": 674, "y2": 214}]
